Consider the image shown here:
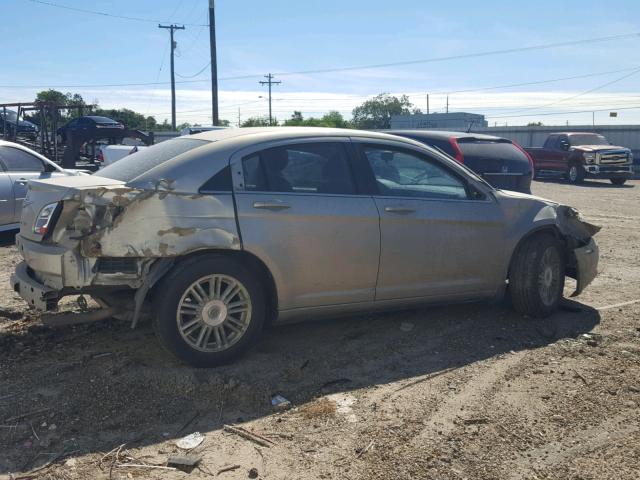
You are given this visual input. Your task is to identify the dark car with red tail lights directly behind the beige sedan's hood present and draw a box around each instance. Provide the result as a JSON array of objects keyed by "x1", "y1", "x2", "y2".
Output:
[{"x1": 385, "y1": 130, "x2": 533, "y2": 193}]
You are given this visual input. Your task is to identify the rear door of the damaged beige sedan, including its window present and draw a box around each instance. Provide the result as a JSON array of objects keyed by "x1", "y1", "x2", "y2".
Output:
[{"x1": 231, "y1": 137, "x2": 380, "y2": 310}]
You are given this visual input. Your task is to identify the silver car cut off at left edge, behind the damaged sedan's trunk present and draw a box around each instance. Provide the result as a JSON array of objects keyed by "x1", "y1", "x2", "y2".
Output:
[{"x1": 0, "y1": 140, "x2": 85, "y2": 232}]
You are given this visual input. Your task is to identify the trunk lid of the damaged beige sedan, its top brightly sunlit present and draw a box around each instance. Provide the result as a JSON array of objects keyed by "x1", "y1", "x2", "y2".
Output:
[{"x1": 20, "y1": 175, "x2": 125, "y2": 242}]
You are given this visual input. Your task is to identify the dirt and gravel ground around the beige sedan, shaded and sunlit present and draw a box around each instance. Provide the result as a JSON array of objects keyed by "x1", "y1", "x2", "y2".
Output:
[{"x1": 0, "y1": 181, "x2": 640, "y2": 480}]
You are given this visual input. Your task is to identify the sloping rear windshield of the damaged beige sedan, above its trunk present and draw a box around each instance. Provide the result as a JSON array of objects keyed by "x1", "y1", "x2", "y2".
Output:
[{"x1": 94, "y1": 138, "x2": 209, "y2": 182}]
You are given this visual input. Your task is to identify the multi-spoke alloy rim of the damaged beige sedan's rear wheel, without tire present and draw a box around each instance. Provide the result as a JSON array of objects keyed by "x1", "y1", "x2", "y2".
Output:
[{"x1": 176, "y1": 274, "x2": 251, "y2": 353}]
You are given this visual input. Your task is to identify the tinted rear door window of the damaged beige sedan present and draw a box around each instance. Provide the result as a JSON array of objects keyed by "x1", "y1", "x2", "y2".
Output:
[{"x1": 242, "y1": 142, "x2": 356, "y2": 194}]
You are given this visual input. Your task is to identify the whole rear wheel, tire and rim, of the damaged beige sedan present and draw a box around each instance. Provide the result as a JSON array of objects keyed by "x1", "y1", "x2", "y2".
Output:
[{"x1": 153, "y1": 255, "x2": 266, "y2": 367}]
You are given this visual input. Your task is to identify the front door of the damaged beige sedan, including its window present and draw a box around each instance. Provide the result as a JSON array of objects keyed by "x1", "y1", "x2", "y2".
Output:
[{"x1": 356, "y1": 140, "x2": 504, "y2": 301}]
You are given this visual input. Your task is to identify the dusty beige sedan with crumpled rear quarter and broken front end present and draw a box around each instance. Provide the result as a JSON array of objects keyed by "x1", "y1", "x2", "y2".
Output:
[{"x1": 11, "y1": 127, "x2": 599, "y2": 366}]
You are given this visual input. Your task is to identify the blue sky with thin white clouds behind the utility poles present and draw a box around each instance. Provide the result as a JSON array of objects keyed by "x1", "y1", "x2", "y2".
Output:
[{"x1": 0, "y1": 0, "x2": 640, "y2": 125}]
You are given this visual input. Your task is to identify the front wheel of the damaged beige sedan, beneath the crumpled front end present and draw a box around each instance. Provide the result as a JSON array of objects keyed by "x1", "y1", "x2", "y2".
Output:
[{"x1": 509, "y1": 234, "x2": 565, "y2": 318}]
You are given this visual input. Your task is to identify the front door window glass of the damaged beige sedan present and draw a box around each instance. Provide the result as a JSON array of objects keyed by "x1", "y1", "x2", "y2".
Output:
[{"x1": 364, "y1": 146, "x2": 468, "y2": 200}]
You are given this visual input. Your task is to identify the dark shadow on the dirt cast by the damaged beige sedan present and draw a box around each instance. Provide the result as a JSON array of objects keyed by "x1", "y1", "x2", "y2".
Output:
[{"x1": 0, "y1": 302, "x2": 600, "y2": 473}]
